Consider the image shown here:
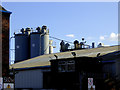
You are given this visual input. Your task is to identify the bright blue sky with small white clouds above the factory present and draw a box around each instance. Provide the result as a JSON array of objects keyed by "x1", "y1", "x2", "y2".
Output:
[{"x1": 2, "y1": 2, "x2": 119, "y2": 63}]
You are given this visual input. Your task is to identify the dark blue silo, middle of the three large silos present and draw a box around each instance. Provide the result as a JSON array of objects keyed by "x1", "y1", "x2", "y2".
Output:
[{"x1": 30, "y1": 27, "x2": 42, "y2": 58}]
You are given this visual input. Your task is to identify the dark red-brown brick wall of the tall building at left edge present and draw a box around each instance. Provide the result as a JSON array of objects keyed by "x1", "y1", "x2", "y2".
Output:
[{"x1": 2, "y1": 13, "x2": 10, "y2": 76}]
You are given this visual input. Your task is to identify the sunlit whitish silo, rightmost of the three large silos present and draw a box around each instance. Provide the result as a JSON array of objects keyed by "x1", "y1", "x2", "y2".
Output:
[{"x1": 41, "y1": 26, "x2": 49, "y2": 55}]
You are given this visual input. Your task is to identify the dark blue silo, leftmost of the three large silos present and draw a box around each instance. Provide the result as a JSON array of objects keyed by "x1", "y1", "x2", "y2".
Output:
[{"x1": 15, "y1": 33, "x2": 29, "y2": 62}]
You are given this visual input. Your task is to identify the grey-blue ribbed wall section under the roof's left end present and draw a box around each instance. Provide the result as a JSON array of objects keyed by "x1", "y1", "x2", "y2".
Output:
[{"x1": 15, "y1": 69, "x2": 43, "y2": 88}]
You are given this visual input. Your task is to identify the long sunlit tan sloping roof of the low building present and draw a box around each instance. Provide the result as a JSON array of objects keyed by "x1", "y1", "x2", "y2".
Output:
[{"x1": 10, "y1": 45, "x2": 120, "y2": 69}]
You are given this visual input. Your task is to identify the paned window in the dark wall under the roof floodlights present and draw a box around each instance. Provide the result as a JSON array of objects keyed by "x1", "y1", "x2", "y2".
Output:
[{"x1": 58, "y1": 60, "x2": 75, "y2": 72}]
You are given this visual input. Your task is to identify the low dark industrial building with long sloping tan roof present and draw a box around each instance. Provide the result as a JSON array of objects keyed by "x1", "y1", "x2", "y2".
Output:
[{"x1": 10, "y1": 45, "x2": 120, "y2": 90}]
